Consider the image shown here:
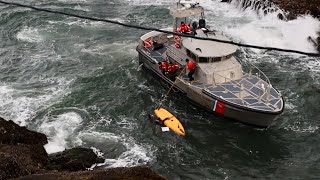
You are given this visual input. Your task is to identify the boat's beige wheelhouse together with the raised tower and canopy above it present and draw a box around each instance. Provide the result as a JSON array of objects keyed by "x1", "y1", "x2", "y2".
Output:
[{"x1": 168, "y1": 1, "x2": 243, "y2": 84}]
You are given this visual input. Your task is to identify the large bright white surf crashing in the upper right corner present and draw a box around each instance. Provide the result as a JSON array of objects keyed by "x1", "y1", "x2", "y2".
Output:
[{"x1": 204, "y1": 1, "x2": 320, "y2": 53}]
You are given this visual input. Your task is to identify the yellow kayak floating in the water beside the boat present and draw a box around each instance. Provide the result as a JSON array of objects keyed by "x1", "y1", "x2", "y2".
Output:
[{"x1": 154, "y1": 108, "x2": 186, "y2": 136}]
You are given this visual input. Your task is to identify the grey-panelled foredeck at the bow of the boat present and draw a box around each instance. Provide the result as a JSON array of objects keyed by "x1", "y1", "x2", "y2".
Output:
[{"x1": 190, "y1": 74, "x2": 283, "y2": 111}]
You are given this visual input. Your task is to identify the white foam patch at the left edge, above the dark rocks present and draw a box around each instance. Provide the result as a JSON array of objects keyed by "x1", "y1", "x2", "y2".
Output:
[{"x1": 0, "y1": 78, "x2": 70, "y2": 126}]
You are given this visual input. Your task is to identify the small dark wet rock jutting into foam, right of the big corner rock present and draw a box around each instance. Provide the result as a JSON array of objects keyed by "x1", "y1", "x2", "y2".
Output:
[{"x1": 47, "y1": 147, "x2": 104, "y2": 171}]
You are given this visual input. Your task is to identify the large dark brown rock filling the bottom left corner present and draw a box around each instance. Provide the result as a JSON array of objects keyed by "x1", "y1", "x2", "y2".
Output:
[{"x1": 0, "y1": 118, "x2": 49, "y2": 179}]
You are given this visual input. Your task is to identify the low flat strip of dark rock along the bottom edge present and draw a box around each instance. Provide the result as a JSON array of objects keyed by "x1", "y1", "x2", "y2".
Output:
[{"x1": 18, "y1": 167, "x2": 166, "y2": 180}]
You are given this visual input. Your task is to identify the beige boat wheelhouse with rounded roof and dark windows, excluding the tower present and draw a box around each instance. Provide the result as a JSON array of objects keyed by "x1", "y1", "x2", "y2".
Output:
[{"x1": 180, "y1": 29, "x2": 243, "y2": 84}]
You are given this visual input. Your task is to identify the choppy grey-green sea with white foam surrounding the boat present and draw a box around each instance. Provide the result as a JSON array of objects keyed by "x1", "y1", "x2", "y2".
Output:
[{"x1": 0, "y1": 0, "x2": 320, "y2": 179}]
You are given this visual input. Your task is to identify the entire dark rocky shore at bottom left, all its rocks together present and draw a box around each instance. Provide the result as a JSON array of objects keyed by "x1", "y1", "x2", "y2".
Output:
[{"x1": 0, "y1": 118, "x2": 165, "y2": 180}]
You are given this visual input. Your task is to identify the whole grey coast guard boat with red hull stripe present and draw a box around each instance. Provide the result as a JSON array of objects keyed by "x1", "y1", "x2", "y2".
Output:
[{"x1": 137, "y1": 0, "x2": 284, "y2": 127}]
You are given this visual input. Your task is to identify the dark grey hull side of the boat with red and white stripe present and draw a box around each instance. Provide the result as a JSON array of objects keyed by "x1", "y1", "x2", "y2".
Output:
[{"x1": 137, "y1": 46, "x2": 283, "y2": 128}]
